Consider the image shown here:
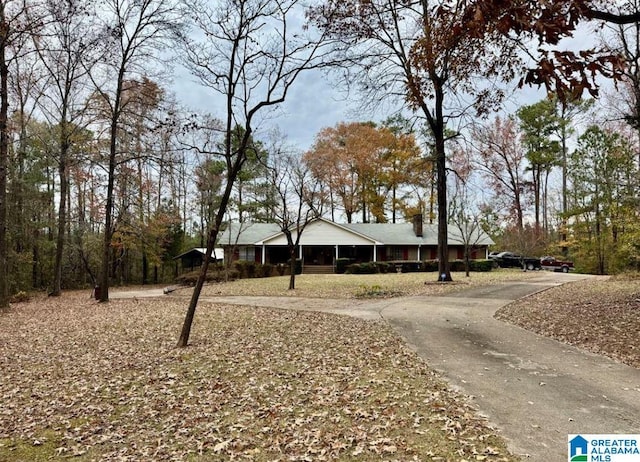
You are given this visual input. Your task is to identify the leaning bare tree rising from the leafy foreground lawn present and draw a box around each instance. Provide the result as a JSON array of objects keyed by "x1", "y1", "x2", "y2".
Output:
[{"x1": 178, "y1": 0, "x2": 336, "y2": 347}]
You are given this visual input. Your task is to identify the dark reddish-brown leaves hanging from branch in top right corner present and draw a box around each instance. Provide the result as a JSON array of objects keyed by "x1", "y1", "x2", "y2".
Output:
[{"x1": 452, "y1": 0, "x2": 634, "y2": 100}]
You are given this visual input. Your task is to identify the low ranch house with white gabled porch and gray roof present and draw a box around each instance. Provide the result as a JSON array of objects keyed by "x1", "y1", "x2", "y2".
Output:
[{"x1": 218, "y1": 215, "x2": 494, "y2": 272}]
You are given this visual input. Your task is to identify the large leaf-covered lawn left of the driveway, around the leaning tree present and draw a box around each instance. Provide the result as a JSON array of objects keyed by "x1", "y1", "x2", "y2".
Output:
[{"x1": 0, "y1": 293, "x2": 517, "y2": 462}]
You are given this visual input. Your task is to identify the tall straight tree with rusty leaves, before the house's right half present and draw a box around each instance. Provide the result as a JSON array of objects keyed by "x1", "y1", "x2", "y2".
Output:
[{"x1": 312, "y1": 0, "x2": 514, "y2": 281}]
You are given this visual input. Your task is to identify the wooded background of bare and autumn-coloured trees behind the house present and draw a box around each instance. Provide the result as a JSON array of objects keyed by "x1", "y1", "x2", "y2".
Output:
[{"x1": 0, "y1": 0, "x2": 640, "y2": 304}]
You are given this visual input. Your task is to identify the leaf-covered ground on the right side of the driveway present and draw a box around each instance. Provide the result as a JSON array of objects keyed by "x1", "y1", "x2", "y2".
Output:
[{"x1": 496, "y1": 277, "x2": 640, "y2": 368}]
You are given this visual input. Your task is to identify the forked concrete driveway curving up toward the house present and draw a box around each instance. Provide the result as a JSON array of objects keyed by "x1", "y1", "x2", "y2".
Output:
[{"x1": 114, "y1": 272, "x2": 640, "y2": 462}]
